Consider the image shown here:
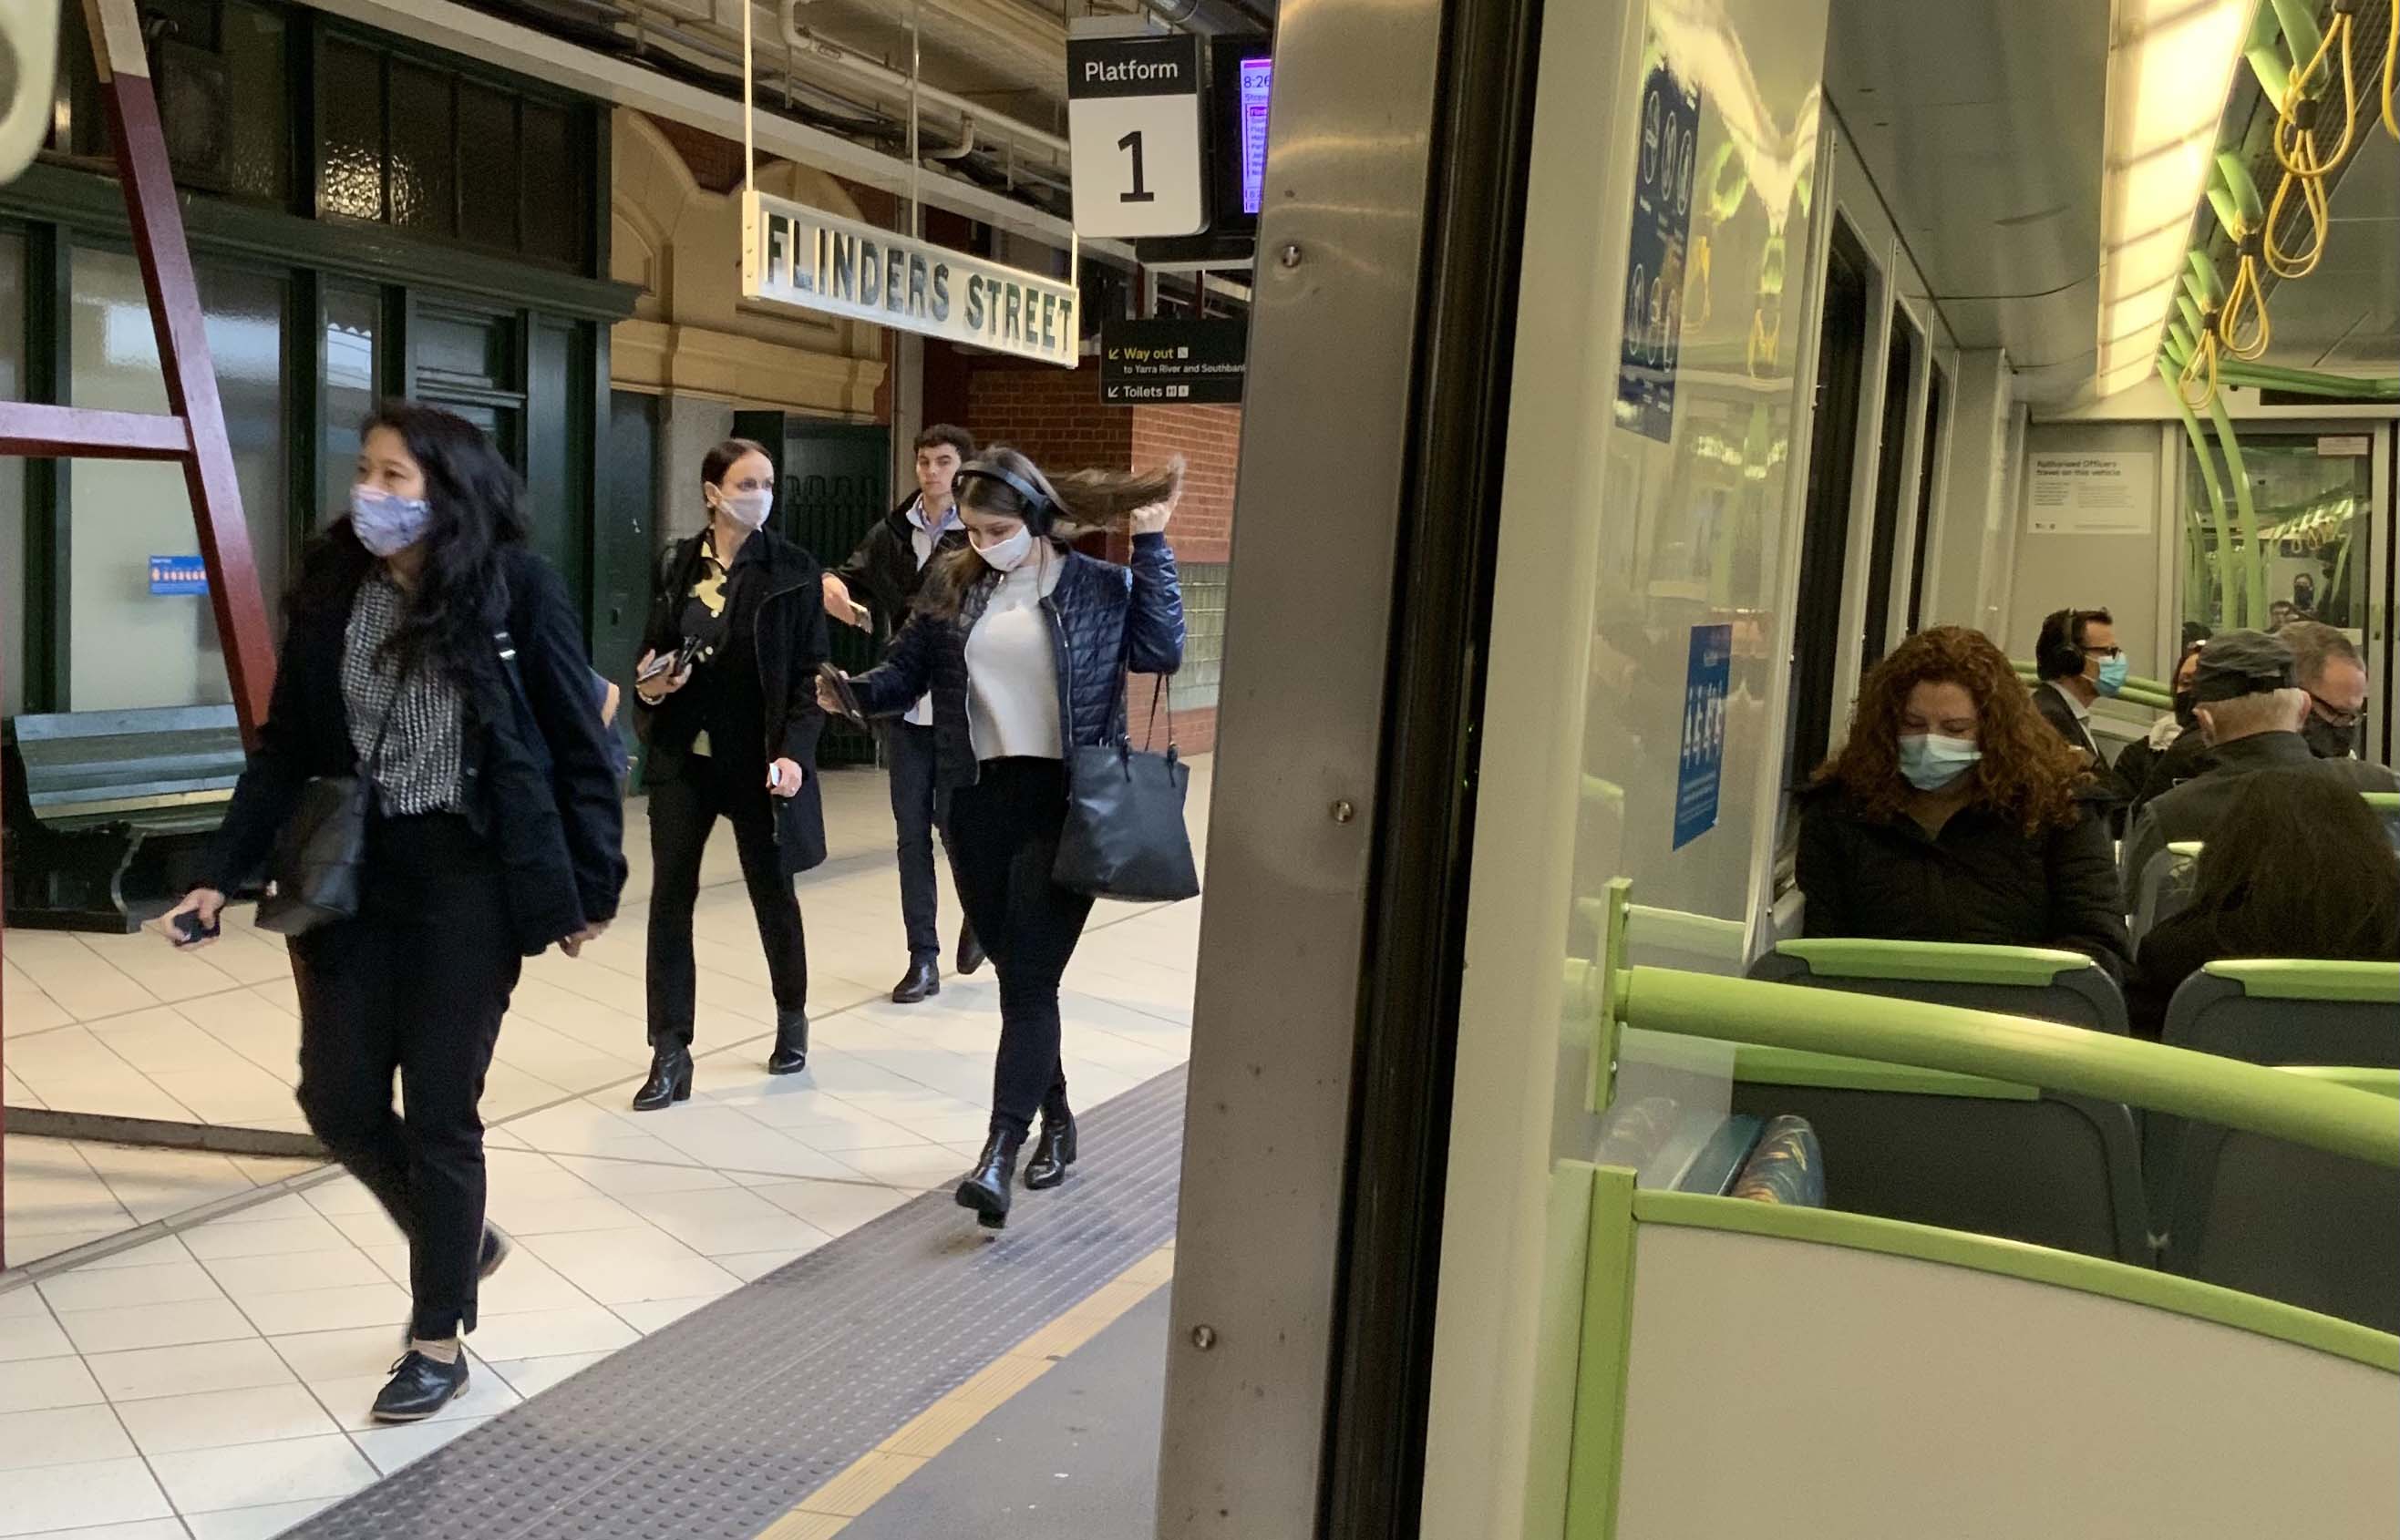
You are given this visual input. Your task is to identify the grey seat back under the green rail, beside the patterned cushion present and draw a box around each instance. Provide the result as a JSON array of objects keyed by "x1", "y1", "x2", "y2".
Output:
[{"x1": 1733, "y1": 1046, "x2": 2150, "y2": 1267}]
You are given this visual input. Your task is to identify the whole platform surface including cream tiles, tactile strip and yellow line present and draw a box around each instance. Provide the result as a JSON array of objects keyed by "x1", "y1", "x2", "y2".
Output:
[{"x1": 0, "y1": 760, "x2": 1207, "y2": 1540}]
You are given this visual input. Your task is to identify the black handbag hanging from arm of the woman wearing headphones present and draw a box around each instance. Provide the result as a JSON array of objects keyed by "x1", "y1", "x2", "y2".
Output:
[{"x1": 1051, "y1": 655, "x2": 1200, "y2": 904}]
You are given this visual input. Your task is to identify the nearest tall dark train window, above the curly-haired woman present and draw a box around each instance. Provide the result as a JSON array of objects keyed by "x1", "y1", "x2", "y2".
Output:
[{"x1": 1783, "y1": 221, "x2": 1870, "y2": 789}]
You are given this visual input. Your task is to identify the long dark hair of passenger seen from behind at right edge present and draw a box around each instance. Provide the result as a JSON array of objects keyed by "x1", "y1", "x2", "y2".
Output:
[{"x1": 2184, "y1": 770, "x2": 2400, "y2": 960}]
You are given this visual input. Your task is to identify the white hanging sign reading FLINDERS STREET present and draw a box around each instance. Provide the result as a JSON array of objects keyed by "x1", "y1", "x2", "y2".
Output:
[{"x1": 742, "y1": 192, "x2": 1082, "y2": 369}]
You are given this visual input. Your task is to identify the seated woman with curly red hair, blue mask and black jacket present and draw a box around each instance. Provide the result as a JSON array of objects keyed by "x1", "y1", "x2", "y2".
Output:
[{"x1": 1797, "y1": 626, "x2": 2127, "y2": 971}]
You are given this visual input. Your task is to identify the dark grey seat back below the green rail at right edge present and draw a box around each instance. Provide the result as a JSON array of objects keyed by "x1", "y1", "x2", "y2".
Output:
[{"x1": 2162, "y1": 1065, "x2": 2400, "y2": 1331}]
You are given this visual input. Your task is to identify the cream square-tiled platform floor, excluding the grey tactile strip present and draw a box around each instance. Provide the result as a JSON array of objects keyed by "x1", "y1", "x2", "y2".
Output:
[{"x1": 0, "y1": 763, "x2": 1207, "y2": 1540}]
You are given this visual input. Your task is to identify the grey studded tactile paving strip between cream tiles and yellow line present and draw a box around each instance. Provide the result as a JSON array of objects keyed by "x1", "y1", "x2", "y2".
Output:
[{"x1": 285, "y1": 1067, "x2": 1183, "y2": 1540}]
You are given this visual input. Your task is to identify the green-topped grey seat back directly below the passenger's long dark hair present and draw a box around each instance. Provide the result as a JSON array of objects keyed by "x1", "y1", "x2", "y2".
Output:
[{"x1": 2141, "y1": 957, "x2": 2400, "y2": 1267}]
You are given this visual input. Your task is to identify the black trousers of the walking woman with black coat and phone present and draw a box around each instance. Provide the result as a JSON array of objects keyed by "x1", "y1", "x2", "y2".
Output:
[{"x1": 645, "y1": 754, "x2": 809, "y2": 1048}]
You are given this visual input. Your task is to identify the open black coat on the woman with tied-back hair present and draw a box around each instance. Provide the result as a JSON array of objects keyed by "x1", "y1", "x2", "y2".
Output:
[{"x1": 633, "y1": 530, "x2": 826, "y2": 876}]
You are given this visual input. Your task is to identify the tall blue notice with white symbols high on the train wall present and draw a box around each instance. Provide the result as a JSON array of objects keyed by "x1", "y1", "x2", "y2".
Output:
[{"x1": 1618, "y1": 34, "x2": 1699, "y2": 444}]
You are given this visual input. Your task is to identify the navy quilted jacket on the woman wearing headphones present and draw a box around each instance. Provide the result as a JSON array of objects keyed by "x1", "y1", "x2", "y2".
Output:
[{"x1": 852, "y1": 535, "x2": 1183, "y2": 789}]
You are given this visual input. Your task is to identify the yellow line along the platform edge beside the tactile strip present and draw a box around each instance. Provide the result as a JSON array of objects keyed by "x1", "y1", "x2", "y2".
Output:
[{"x1": 758, "y1": 1243, "x2": 1176, "y2": 1540}]
